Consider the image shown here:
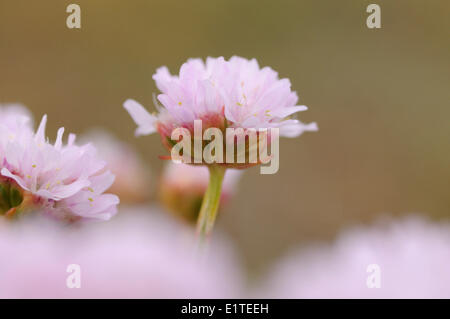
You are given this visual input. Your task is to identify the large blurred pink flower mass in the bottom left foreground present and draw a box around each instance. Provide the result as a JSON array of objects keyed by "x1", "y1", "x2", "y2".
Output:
[{"x1": 0, "y1": 209, "x2": 241, "y2": 298}]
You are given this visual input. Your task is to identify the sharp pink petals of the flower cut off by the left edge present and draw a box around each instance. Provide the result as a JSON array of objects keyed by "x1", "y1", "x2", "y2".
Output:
[{"x1": 0, "y1": 106, "x2": 119, "y2": 220}]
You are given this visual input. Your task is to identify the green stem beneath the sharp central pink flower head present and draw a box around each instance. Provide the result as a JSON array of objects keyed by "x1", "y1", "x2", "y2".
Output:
[{"x1": 197, "y1": 165, "x2": 226, "y2": 242}]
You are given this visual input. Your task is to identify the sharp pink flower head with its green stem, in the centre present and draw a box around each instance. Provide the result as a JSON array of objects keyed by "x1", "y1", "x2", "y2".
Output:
[{"x1": 124, "y1": 57, "x2": 317, "y2": 237}]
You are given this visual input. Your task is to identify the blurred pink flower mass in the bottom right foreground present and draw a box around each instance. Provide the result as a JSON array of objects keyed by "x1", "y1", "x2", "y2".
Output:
[{"x1": 256, "y1": 217, "x2": 450, "y2": 298}]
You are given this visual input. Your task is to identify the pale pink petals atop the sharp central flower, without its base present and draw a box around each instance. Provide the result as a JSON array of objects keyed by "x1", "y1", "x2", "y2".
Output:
[{"x1": 124, "y1": 56, "x2": 317, "y2": 137}]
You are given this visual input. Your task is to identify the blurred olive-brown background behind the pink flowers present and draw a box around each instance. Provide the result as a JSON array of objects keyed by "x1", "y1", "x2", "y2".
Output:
[{"x1": 0, "y1": 0, "x2": 450, "y2": 271}]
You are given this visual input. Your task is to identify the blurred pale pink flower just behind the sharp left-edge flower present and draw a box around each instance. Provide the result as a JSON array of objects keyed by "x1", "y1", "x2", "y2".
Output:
[{"x1": 81, "y1": 130, "x2": 151, "y2": 203}]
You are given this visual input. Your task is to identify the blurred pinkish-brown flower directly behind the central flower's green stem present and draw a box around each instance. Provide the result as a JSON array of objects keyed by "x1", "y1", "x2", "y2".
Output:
[{"x1": 159, "y1": 162, "x2": 242, "y2": 222}]
